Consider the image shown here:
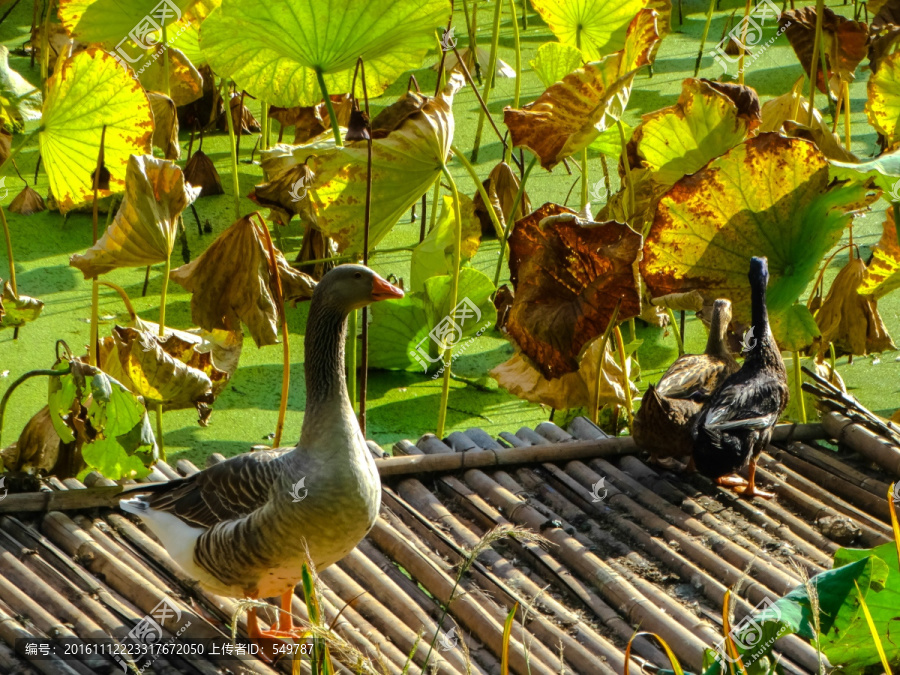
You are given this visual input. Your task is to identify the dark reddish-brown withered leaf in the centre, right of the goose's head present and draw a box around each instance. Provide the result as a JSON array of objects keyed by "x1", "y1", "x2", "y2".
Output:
[{"x1": 507, "y1": 204, "x2": 642, "y2": 379}]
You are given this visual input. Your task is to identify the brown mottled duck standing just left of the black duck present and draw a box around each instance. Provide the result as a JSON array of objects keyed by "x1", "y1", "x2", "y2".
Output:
[{"x1": 634, "y1": 299, "x2": 739, "y2": 471}]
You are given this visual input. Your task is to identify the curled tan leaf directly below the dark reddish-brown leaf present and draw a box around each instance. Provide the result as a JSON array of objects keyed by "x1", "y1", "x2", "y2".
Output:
[{"x1": 490, "y1": 338, "x2": 639, "y2": 410}]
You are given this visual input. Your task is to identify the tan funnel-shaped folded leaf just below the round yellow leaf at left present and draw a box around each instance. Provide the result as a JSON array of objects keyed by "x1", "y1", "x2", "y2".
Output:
[{"x1": 69, "y1": 155, "x2": 200, "y2": 279}]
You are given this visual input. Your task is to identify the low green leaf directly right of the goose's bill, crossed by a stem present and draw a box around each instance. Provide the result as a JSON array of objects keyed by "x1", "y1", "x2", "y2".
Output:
[{"x1": 369, "y1": 267, "x2": 497, "y2": 375}]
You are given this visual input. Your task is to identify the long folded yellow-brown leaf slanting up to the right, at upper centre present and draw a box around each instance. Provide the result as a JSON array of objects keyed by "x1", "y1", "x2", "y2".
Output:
[{"x1": 503, "y1": 10, "x2": 659, "y2": 169}]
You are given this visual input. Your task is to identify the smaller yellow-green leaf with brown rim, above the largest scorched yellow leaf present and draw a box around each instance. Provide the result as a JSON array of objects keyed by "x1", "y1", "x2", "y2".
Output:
[{"x1": 632, "y1": 79, "x2": 759, "y2": 185}]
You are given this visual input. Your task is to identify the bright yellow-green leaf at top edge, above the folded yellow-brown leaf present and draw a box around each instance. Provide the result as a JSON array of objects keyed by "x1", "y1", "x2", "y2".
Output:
[{"x1": 531, "y1": 0, "x2": 647, "y2": 61}]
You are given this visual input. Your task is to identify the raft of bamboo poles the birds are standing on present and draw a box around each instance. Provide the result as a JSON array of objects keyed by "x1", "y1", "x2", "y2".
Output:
[{"x1": 0, "y1": 413, "x2": 900, "y2": 675}]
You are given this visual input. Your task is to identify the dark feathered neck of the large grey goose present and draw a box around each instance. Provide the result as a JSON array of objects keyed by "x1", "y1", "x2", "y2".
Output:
[{"x1": 300, "y1": 296, "x2": 359, "y2": 447}]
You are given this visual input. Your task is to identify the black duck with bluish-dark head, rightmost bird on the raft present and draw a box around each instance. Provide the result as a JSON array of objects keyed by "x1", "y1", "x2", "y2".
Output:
[{"x1": 693, "y1": 258, "x2": 789, "y2": 499}]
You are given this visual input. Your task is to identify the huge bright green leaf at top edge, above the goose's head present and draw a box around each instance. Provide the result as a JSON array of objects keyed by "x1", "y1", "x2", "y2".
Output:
[{"x1": 200, "y1": 0, "x2": 450, "y2": 108}]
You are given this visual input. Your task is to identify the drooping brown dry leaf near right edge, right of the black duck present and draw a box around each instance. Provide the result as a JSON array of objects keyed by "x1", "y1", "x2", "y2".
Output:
[{"x1": 816, "y1": 256, "x2": 894, "y2": 356}]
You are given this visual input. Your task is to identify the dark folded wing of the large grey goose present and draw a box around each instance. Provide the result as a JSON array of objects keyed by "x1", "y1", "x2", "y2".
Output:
[{"x1": 128, "y1": 450, "x2": 283, "y2": 527}]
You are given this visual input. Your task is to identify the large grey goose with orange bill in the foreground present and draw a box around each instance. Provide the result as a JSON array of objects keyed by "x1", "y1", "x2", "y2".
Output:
[{"x1": 119, "y1": 265, "x2": 403, "y2": 639}]
